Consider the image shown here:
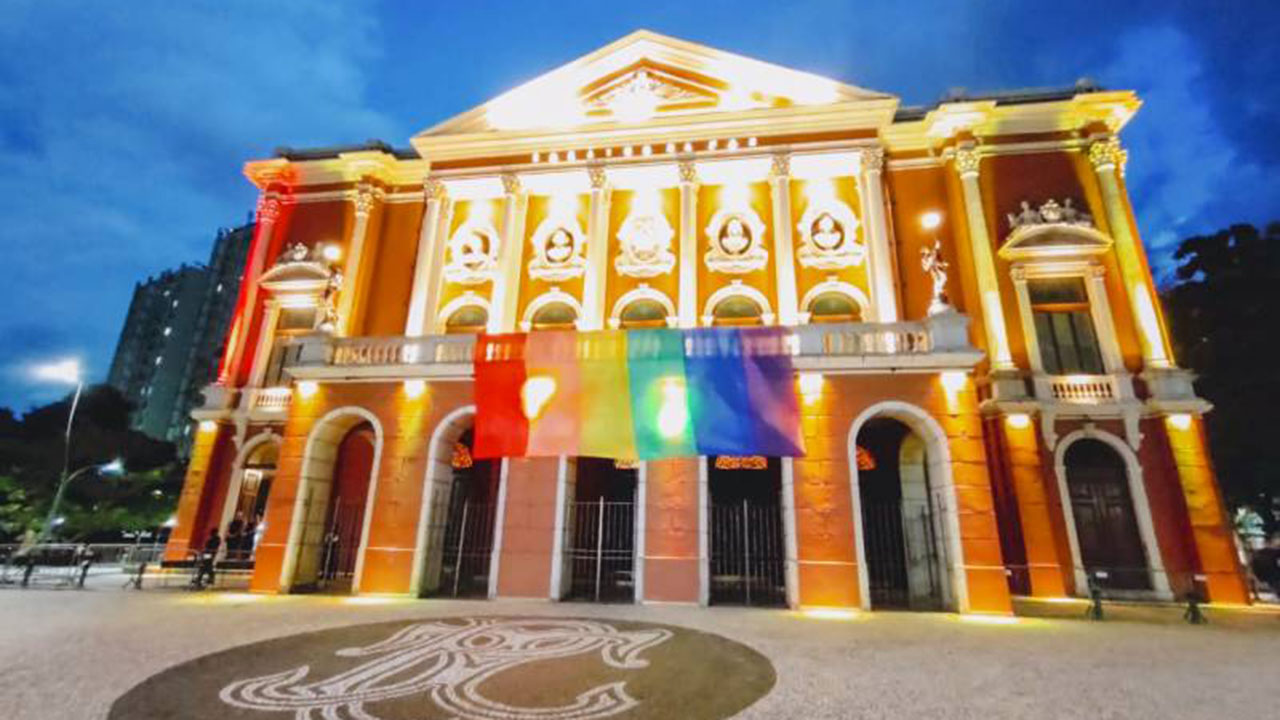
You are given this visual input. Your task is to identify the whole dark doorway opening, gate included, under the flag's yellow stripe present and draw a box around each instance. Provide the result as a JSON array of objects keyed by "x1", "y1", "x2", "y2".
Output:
[{"x1": 561, "y1": 457, "x2": 639, "y2": 602}]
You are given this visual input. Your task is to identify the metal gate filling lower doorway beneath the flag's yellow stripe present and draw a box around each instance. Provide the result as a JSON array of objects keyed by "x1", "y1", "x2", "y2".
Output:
[{"x1": 566, "y1": 497, "x2": 635, "y2": 602}]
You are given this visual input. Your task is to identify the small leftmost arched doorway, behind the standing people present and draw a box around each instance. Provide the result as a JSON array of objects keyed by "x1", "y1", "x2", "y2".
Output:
[{"x1": 221, "y1": 434, "x2": 280, "y2": 568}]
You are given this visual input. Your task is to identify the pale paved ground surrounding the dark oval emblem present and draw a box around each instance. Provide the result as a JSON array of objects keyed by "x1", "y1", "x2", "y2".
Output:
[{"x1": 0, "y1": 578, "x2": 1280, "y2": 720}]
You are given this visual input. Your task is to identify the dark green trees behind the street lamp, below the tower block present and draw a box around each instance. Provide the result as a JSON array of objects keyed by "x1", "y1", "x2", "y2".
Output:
[{"x1": 0, "y1": 386, "x2": 183, "y2": 541}]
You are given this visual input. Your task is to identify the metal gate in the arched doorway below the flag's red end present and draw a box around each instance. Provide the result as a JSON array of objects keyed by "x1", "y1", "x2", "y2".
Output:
[{"x1": 438, "y1": 493, "x2": 497, "y2": 597}]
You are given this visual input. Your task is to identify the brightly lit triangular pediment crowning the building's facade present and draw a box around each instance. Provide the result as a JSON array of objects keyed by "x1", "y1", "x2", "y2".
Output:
[{"x1": 417, "y1": 31, "x2": 895, "y2": 138}]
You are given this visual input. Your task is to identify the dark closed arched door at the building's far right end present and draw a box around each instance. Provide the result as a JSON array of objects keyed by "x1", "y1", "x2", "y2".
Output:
[{"x1": 1062, "y1": 438, "x2": 1151, "y2": 591}]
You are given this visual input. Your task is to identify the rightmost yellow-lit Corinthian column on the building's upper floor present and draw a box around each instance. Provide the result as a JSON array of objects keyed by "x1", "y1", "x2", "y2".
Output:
[{"x1": 1089, "y1": 136, "x2": 1172, "y2": 368}]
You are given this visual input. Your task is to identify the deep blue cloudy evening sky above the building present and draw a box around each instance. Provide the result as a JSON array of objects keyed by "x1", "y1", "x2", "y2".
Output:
[{"x1": 0, "y1": 0, "x2": 1280, "y2": 411}]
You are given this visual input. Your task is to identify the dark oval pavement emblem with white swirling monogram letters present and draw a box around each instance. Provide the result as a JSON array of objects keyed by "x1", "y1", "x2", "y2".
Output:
[{"x1": 108, "y1": 616, "x2": 777, "y2": 720}]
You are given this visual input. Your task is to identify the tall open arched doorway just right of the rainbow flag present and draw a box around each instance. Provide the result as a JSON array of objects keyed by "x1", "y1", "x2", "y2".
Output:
[{"x1": 855, "y1": 418, "x2": 951, "y2": 610}]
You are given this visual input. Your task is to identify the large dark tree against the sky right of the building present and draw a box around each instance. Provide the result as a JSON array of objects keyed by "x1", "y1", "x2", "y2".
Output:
[{"x1": 1164, "y1": 223, "x2": 1280, "y2": 528}]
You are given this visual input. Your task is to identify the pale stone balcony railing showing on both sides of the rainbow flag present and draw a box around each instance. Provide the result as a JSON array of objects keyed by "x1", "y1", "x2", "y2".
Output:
[{"x1": 287, "y1": 313, "x2": 982, "y2": 378}]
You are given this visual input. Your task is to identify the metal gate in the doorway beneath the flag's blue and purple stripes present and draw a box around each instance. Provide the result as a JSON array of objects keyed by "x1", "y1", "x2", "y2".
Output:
[{"x1": 710, "y1": 500, "x2": 787, "y2": 606}]
